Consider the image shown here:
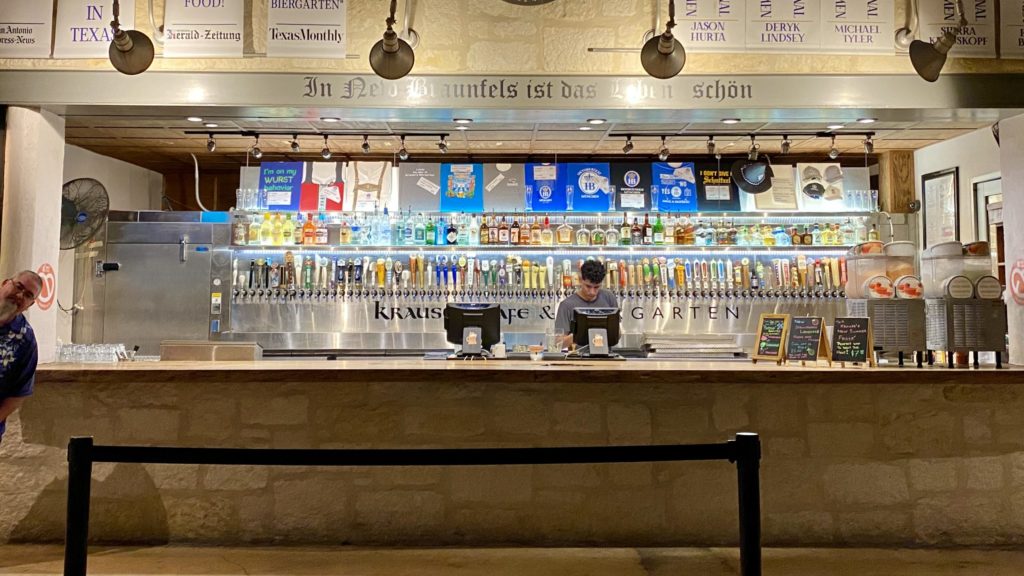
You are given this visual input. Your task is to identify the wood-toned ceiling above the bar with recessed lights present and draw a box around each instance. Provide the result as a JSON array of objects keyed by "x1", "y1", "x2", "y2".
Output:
[{"x1": 66, "y1": 109, "x2": 992, "y2": 173}]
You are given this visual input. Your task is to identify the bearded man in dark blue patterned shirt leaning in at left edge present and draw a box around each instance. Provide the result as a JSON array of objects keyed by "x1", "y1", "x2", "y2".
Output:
[{"x1": 0, "y1": 270, "x2": 43, "y2": 442}]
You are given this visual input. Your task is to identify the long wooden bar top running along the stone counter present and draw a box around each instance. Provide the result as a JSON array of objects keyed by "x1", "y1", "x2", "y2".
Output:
[{"x1": 36, "y1": 358, "x2": 1024, "y2": 384}]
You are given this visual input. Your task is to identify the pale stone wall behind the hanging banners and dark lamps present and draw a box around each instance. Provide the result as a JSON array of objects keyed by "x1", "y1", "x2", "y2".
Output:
[{"x1": 0, "y1": 0, "x2": 1024, "y2": 76}]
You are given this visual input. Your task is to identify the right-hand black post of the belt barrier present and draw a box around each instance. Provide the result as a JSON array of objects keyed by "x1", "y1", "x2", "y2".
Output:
[{"x1": 735, "y1": 433, "x2": 761, "y2": 576}]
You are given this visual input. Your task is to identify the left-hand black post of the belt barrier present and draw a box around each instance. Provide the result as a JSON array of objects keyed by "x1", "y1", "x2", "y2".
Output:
[{"x1": 65, "y1": 438, "x2": 92, "y2": 576}]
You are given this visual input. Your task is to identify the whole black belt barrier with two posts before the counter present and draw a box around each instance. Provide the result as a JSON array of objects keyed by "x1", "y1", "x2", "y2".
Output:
[{"x1": 63, "y1": 434, "x2": 761, "y2": 576}]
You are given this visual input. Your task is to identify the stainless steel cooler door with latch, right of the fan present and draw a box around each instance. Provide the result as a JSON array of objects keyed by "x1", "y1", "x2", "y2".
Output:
[{"x1": 103, "y1": 244, "x2": 210, "y2": 355}]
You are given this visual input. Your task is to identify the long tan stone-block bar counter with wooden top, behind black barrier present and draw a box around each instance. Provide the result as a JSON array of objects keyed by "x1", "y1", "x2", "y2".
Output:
[{"x1": 0, "y1": 359, "x2": 1024, "y2": 546}]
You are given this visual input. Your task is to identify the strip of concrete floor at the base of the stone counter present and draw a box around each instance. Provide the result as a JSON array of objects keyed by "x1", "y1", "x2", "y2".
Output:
[{"x1": 0, "y1": 545, "x2": 1024, "y2": 576}]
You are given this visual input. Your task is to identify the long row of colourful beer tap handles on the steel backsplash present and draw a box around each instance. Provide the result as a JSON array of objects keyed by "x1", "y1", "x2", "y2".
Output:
[{"x1": 232, "y1": 252, "x2": 846, "y2": 302}]
